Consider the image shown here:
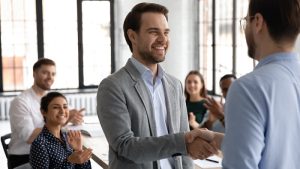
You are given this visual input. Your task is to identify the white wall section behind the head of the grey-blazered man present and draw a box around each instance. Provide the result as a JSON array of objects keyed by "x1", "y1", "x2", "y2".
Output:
[{"x1": 115, "y1": 0, "x2": 196, "y2": 82}]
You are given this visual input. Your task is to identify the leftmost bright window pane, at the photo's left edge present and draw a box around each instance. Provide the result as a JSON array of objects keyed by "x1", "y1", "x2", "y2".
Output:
[{"x1": 0, "y1": 0, "x2": 37, "y2": 91}]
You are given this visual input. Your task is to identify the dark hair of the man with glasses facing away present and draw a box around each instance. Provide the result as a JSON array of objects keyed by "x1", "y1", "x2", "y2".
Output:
[{"x1": 248, "y1": 0, "x2": 300, "y2": 42}]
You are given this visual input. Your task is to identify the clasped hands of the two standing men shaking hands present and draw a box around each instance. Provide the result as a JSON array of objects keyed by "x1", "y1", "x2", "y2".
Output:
[{"x1": 185, "y1": 129, "x2": 224, "y2": 160}]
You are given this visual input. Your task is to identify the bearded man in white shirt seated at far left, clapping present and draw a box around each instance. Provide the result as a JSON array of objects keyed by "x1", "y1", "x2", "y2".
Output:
[{"x1": 8, "y1": 58, "x2": 83, "y2": 168}]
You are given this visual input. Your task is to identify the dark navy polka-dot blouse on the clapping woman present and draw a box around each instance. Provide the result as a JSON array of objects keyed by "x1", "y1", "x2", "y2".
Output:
[{"x1": 29, "y1": 126, "x2": 91, "y2": 169}]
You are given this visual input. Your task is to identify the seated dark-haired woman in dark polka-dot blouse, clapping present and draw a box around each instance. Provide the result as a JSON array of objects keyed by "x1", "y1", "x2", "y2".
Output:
[{"x1": 30, "y1": 92, "x2": 92, "y2": 169}]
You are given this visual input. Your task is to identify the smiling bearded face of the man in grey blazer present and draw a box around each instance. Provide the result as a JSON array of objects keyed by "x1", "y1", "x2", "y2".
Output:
[{"x1": 129, "y1": 12, "x2": 170, "y2": 65}]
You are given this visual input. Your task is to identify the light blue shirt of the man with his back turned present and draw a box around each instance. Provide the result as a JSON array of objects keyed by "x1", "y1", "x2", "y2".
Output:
[{"x1": 222, "y1": 52, "x2": 300, "y2": 169}]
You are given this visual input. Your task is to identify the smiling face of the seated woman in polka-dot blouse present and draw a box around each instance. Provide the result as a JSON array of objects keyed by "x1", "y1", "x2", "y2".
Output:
[{"x1": 42, "y1": 97, "x2": 69, "y2": 126}]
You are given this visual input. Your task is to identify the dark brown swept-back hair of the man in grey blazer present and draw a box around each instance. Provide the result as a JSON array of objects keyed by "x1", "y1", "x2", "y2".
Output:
[{"x1": 123, "y1": 2, "x2": 169, "y2": 52}]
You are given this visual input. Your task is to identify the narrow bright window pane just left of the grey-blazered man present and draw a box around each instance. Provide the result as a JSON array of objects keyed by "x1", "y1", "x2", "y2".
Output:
[{"x1": 82, "y1": 1, "x2": 111, "y2": 86}]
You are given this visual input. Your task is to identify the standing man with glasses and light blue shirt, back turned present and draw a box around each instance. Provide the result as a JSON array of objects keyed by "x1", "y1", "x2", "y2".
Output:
[{"x1": 199, "y1": 0, "x2": 300, "y2": 169}]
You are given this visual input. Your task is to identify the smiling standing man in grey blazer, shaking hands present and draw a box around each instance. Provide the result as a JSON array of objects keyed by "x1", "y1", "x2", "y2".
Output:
[{"x1": 97, "y1": 3, "x2": 216, "y2": 169}]
